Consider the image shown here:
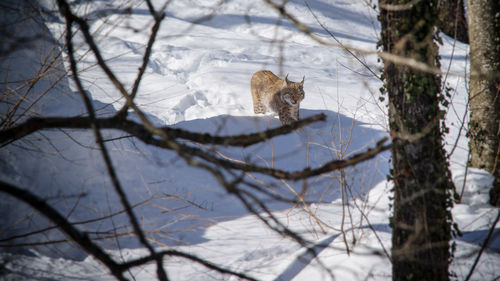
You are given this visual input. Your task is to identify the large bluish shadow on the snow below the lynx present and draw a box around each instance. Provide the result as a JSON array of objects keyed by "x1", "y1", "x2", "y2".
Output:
[{"x1": 1, "y1": 101, "x2": 388, "y2": 259}]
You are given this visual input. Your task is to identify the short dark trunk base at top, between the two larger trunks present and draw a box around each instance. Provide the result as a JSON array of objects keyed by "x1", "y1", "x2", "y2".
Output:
[{"x1": 437, "y1": 0, "x2": 469, "y2": 43}]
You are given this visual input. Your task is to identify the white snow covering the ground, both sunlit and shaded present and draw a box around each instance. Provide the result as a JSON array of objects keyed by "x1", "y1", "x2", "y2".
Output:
[{"x1": 0, "y1": 0, "x2": 500, "y2": 281}]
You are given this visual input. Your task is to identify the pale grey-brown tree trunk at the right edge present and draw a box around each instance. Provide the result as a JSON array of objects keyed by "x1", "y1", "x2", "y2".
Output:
[{"x1": 467, "y1": 0, "x2": 500, "y2": 207}]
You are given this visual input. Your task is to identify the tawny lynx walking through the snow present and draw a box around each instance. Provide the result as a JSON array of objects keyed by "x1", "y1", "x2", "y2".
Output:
[{"x1": 250, "y1": 70, "x2": 305, "y2": 125}]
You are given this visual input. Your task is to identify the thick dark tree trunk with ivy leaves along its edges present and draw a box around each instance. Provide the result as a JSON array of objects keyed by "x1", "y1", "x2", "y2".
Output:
[{"x1": 380, "y1": 0, "x2": 453, "y2": 280}]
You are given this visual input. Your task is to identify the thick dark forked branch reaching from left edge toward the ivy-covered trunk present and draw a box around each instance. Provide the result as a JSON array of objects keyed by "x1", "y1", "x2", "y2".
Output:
[{"x1": 0, "y1": 112, "x2": 391, "y2": 180}]
